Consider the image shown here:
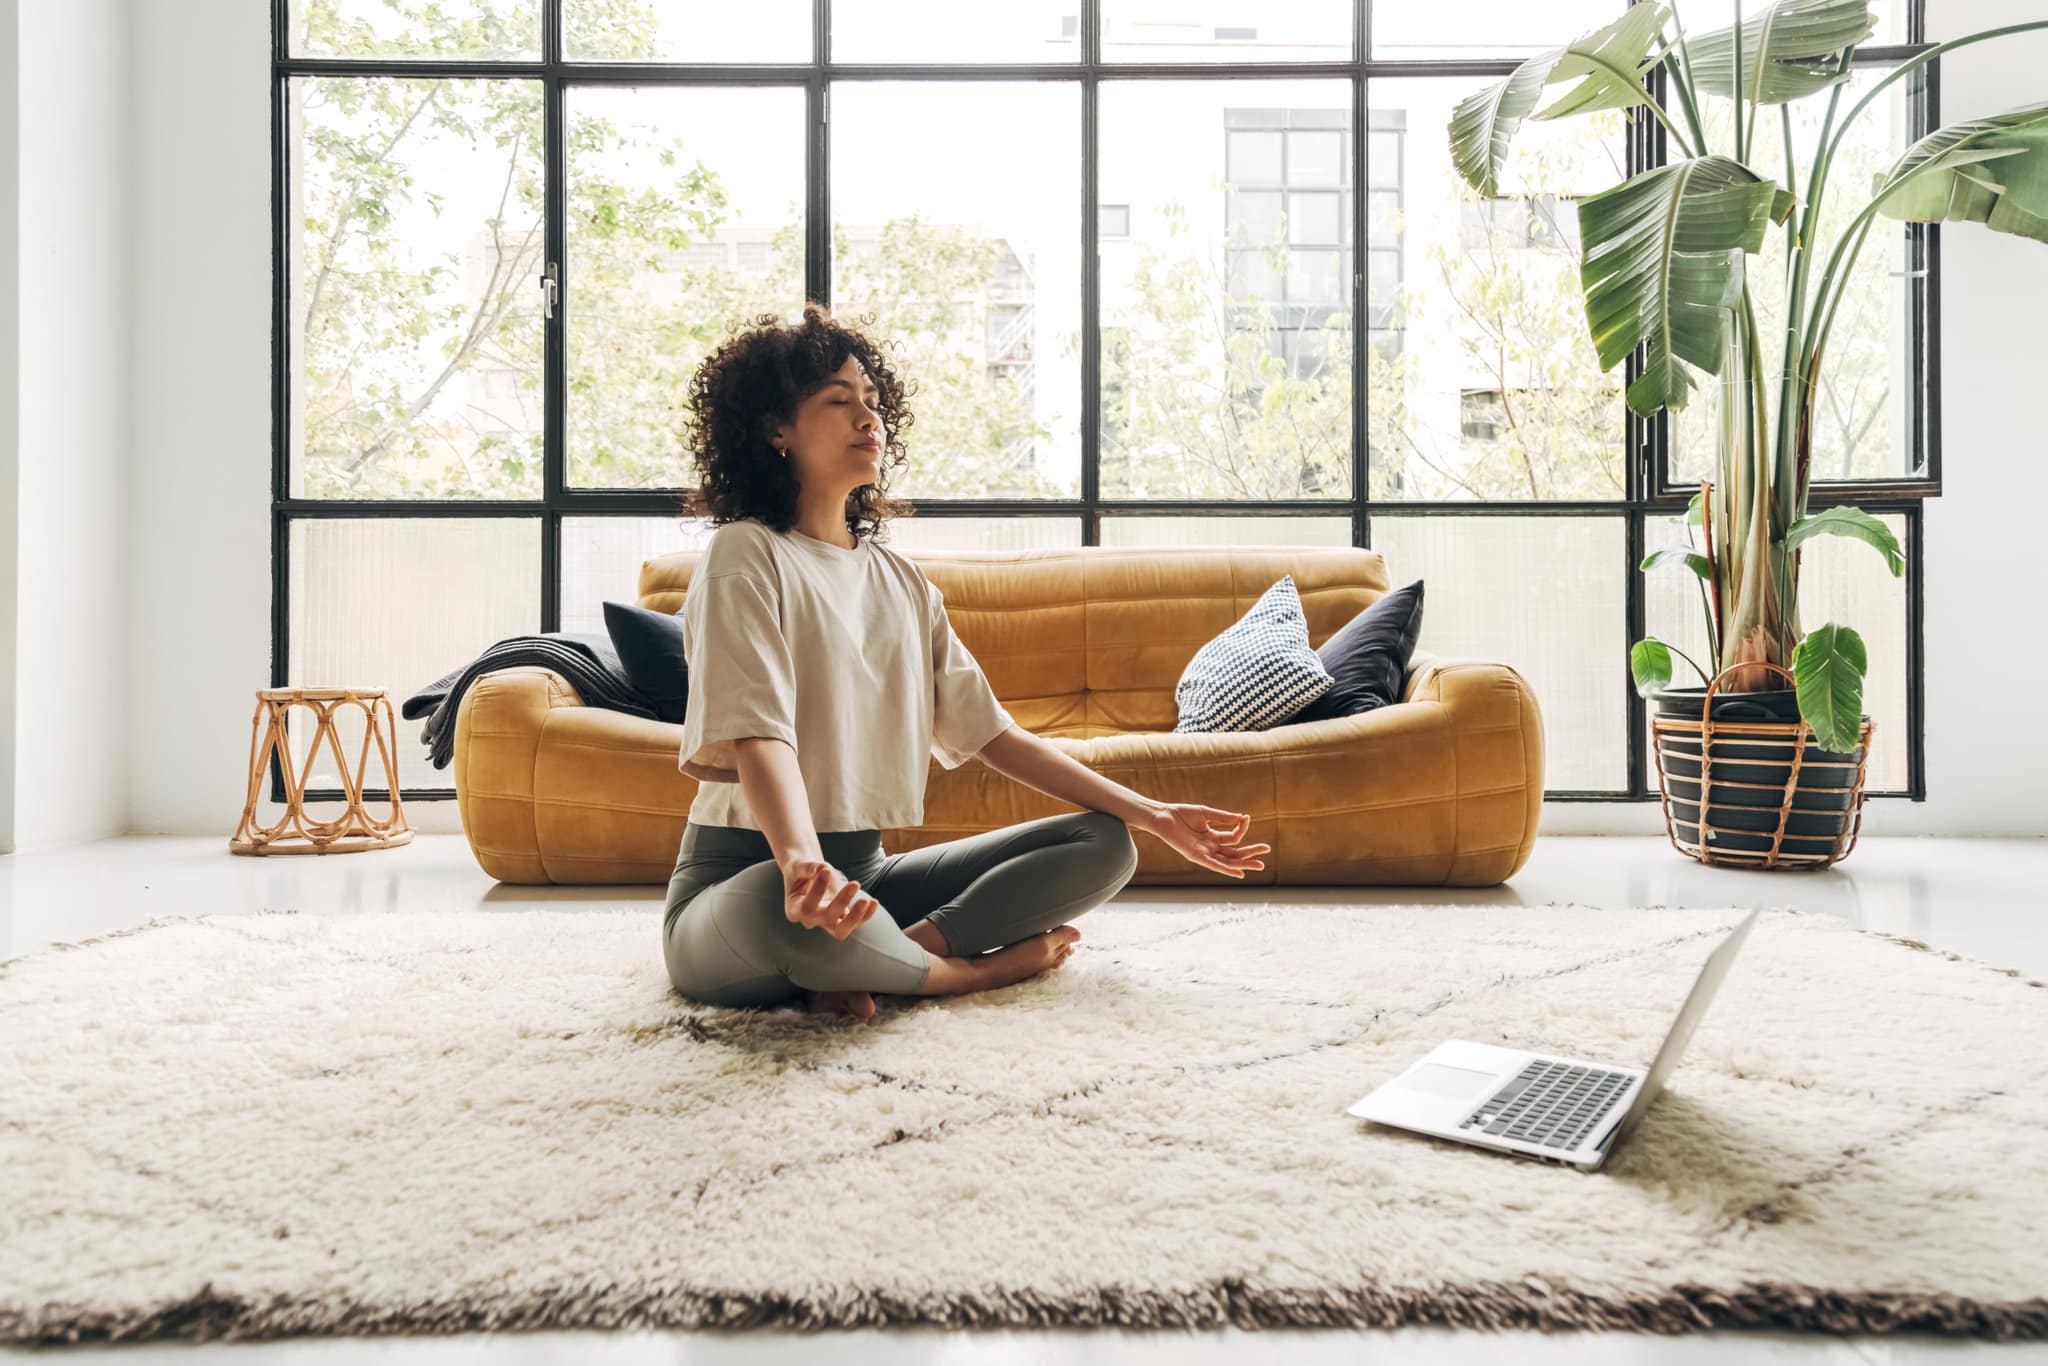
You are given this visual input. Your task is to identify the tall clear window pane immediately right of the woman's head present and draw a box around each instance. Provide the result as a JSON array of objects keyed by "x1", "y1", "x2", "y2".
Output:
[{"x1": 831, "y1": 80, "x2": 1081, "y2": 498}]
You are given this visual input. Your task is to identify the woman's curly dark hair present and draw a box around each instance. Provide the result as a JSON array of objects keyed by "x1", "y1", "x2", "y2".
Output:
[{"x1": 684, "y1": 299, "x2": 913, "y2": 545}]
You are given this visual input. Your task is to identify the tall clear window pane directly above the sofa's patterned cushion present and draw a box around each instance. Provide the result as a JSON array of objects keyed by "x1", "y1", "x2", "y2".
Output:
[{"x1": 1100, "y1": 80, "x2": 1352, "y2": 500}]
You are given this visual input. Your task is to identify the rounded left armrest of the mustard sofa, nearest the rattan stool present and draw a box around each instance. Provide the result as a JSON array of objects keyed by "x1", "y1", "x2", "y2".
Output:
[{"x1": 455, "y1": 664, "x2": 584, "y2": 883}]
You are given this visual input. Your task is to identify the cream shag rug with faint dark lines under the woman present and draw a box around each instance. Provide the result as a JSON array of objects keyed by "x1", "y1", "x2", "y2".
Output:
[{"x1": 0, "y1": 903, "x2": 2048, "y2": 1341}]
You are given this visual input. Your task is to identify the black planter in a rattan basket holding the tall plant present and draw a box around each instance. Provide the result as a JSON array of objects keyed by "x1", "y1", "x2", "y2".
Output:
[{"x1": 1651, "y1": 664, "x2": 1872, "y2": 868}]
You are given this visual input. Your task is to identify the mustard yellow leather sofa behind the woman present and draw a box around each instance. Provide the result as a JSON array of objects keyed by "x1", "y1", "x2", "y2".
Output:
[{"x1": 455, "y1": 547, "x2": 1544, "y2": 887}]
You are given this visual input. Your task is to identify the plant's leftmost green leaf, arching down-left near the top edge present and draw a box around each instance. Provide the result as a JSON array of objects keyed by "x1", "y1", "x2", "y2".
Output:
[{"x1": 1450, "y1": 4, "x2": 1671, "y2": 195}]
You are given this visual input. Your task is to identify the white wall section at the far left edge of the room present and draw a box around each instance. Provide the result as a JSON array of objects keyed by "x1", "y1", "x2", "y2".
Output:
[{"x1": 6, "y1": 0, "x2": 135, "y2": 850}]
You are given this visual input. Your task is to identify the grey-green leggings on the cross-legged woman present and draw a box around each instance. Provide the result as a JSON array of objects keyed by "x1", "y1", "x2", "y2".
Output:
[{"x1": 662, "y1": 811, "x2": 1139, "y2": 1006}]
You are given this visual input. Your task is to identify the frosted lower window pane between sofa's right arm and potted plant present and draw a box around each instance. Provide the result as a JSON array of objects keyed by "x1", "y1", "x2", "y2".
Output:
[{"x1": 1372, "y1": 512, "x2": 1628, "y2": 793}]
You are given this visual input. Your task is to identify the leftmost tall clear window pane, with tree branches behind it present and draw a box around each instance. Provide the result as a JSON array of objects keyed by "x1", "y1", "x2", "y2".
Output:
[{"x1": 285, "y1": 76, "x2": 545, "y2": 498}]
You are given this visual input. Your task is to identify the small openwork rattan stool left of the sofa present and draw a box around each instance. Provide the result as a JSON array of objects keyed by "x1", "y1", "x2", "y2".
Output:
[{"x1": 227, "y1": 688, "x2": 412, "y2": 854}]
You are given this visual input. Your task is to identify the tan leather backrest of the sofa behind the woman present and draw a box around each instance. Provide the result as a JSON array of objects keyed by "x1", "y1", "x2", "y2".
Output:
[{"x1": 639, "y1": 545, "x2": 1389, "y2": 739}]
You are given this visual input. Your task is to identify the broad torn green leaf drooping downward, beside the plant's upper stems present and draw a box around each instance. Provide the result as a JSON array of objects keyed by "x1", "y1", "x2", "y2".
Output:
[{"x1": 1579, "y1": 156, "x2": 1792, "y2": 418}]
